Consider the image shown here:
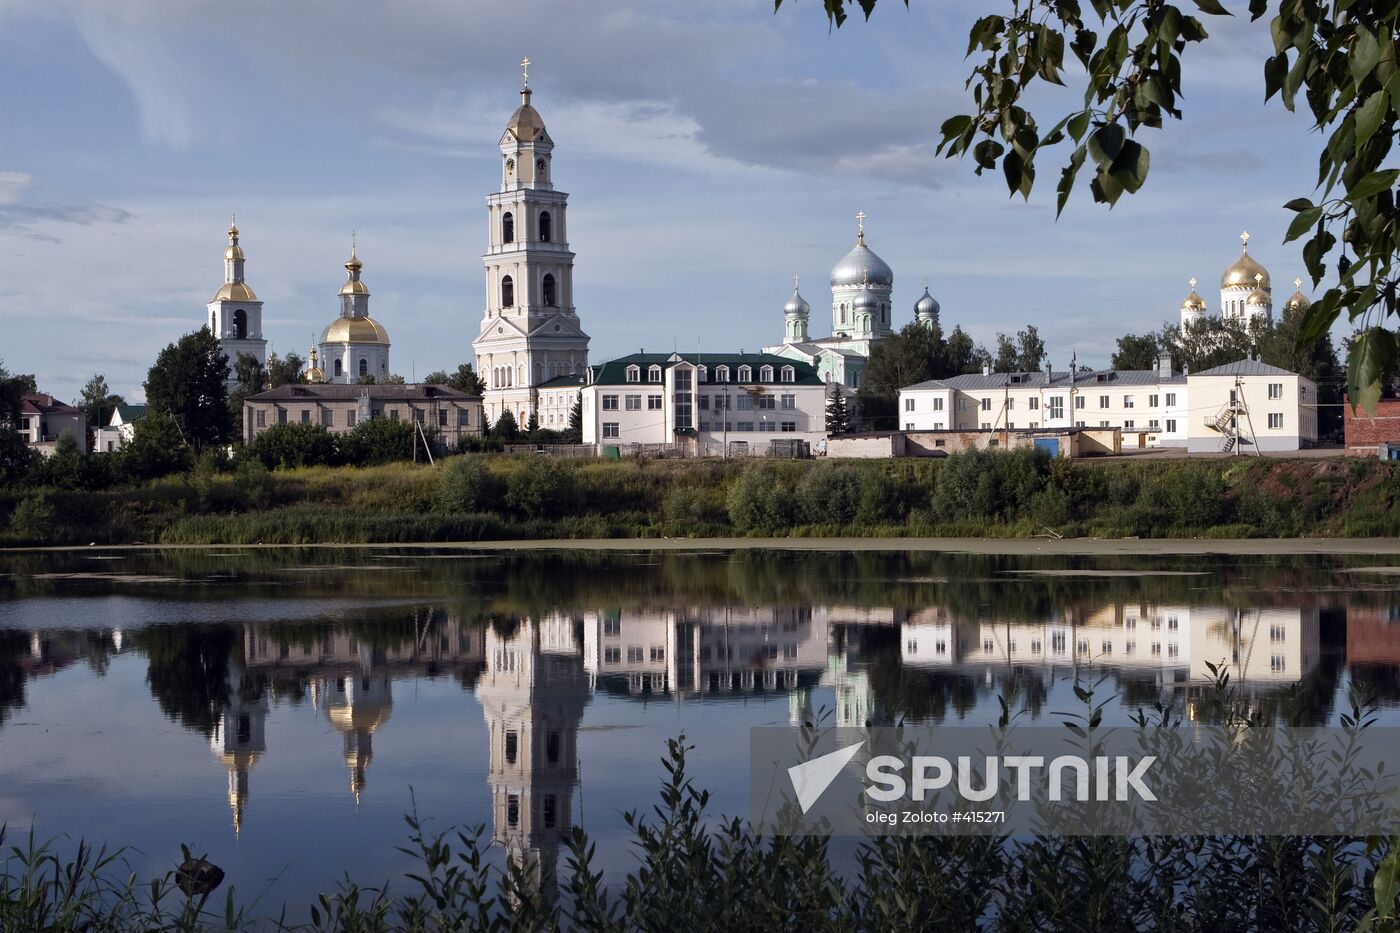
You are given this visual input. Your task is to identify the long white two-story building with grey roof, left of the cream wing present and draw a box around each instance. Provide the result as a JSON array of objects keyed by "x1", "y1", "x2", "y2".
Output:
[{"x1": 899, "y1": 356, "x2": 1189, "y2": 447}]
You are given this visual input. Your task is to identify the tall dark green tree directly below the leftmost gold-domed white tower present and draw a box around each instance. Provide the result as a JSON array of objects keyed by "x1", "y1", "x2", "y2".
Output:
[{"x1": 146, "y1": 328, "x2": 232, "y2": 450}]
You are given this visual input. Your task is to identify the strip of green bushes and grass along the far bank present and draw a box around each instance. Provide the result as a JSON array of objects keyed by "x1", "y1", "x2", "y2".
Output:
[{"x1": 0, "y1": 450, "x2": 1400, "y2": 546}]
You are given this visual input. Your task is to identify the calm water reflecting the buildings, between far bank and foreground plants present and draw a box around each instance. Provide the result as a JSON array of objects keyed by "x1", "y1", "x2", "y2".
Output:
[{"x1": 0, "y1": 549, "x2": 1400, "y2": 913}]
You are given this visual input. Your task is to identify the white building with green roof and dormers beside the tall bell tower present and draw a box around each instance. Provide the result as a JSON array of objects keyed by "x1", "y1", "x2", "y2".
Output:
[{"x1": 577, "y1": 352, "x2": 826, "y2": 455}]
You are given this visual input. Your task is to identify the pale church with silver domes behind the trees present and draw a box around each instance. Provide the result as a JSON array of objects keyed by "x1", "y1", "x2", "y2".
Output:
[{"x1": 763, "y1": 212, "x2": 939, "y2": 391}]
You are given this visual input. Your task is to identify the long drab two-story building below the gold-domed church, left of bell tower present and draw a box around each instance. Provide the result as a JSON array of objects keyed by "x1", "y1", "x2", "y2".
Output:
[{"x1": 244, "y1": 382, "x2": 482, "y2": 445}]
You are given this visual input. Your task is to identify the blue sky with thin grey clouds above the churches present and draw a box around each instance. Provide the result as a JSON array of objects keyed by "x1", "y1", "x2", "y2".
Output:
[{"x1": 0, "y1": 0, "x2": 1326, "y2": 401}]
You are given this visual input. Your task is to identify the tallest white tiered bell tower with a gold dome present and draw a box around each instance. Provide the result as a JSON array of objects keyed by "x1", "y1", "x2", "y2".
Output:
[{"x1": 472, "y1": 68, "x2": 588, "y2": 430}]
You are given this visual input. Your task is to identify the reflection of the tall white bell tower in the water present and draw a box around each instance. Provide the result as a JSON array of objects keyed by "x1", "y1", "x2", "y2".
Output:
[{"x1": 476, "y1": 615, "x2": 588, "y2": 901}]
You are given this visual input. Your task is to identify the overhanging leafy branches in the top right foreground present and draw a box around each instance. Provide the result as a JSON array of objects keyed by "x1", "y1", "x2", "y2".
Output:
[{"x1": 774, "y1": 0, "x2": 1400, "y2": 408}]
